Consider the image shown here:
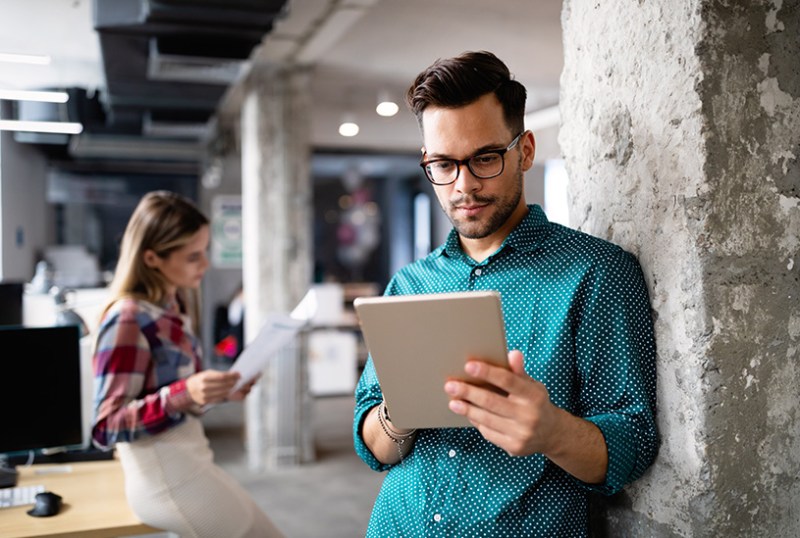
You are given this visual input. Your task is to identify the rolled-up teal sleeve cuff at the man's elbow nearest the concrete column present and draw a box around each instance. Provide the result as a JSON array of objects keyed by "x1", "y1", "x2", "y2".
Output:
[{"x1": 582, "y1": 415, "x2": 638, "y2": 495}]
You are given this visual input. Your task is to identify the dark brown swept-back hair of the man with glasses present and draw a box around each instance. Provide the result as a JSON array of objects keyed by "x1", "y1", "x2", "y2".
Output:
[{"x1": 406, "y1": 51, "x2": 527, "y2": 132}]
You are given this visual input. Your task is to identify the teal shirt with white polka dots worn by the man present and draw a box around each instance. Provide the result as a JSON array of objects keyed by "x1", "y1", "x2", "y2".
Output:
[{"x1": 353, "y1": 205, "x2": 658, "y2": 538}]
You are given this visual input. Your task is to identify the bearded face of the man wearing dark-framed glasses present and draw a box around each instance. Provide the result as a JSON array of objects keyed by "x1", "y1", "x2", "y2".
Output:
[{"x1": 422, "y1": 94, "x2": 534, "y2": 240}]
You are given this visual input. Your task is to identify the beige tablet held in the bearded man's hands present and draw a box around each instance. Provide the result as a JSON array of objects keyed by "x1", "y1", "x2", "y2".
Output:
[{"x1": 353, "y1": 291, "x2": 508, "y2": 428}]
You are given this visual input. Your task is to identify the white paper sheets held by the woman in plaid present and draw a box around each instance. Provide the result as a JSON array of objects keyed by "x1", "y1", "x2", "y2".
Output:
[{"x1": 231, "y1": 314, "x2": 307, "y2": 393}]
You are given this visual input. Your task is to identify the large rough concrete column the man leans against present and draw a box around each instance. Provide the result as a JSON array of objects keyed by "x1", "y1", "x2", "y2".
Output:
[{"x1": 559, "y1": 0, "x2": 800, "y2": 537}]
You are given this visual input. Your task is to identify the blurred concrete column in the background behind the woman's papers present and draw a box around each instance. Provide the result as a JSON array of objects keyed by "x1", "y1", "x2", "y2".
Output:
[{"x1": 241, "y1": 68, "x2": 312, "y2": 470}]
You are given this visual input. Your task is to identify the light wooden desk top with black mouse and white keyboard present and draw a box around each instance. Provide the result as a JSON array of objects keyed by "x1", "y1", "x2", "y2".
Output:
[{"x1": 0, "y1": 459, "x2": 161, "y2": 538}]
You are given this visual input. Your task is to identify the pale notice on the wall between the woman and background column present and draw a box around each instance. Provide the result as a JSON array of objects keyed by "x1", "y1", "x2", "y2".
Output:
[{"x1": 211, "y1": 195, "x2": 242, "y2": 268}]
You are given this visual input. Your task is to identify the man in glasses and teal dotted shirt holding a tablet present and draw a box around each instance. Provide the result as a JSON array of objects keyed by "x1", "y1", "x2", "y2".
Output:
[{"x1": 353, "y1": 52, "x2": 658, "y2": 538}]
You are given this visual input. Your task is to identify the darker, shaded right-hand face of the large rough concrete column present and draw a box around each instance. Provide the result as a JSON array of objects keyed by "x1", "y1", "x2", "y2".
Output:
[{"x1": 697, "y1": 0, "x2": 800, "y2": 537}]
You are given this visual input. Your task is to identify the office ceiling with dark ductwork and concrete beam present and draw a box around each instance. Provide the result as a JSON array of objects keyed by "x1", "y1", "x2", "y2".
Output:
[{"x1": 0, "y1": 0, "x2": 562, "y2": 170}]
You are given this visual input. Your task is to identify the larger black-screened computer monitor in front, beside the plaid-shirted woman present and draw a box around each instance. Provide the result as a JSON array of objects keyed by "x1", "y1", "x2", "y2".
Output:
[{"x1": 0, "y1": 325, "x2": 84, "y2": 457}]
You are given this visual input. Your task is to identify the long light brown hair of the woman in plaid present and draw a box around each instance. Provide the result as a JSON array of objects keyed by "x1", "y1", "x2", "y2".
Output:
[{"x1": 106, "y1": 191, "x2": 209, "y2": 319}]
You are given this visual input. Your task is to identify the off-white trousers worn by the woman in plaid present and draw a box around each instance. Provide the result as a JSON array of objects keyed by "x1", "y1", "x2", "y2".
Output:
[{"x1": 117, "y1": 416, "x2": 283, "y2": 538}]
